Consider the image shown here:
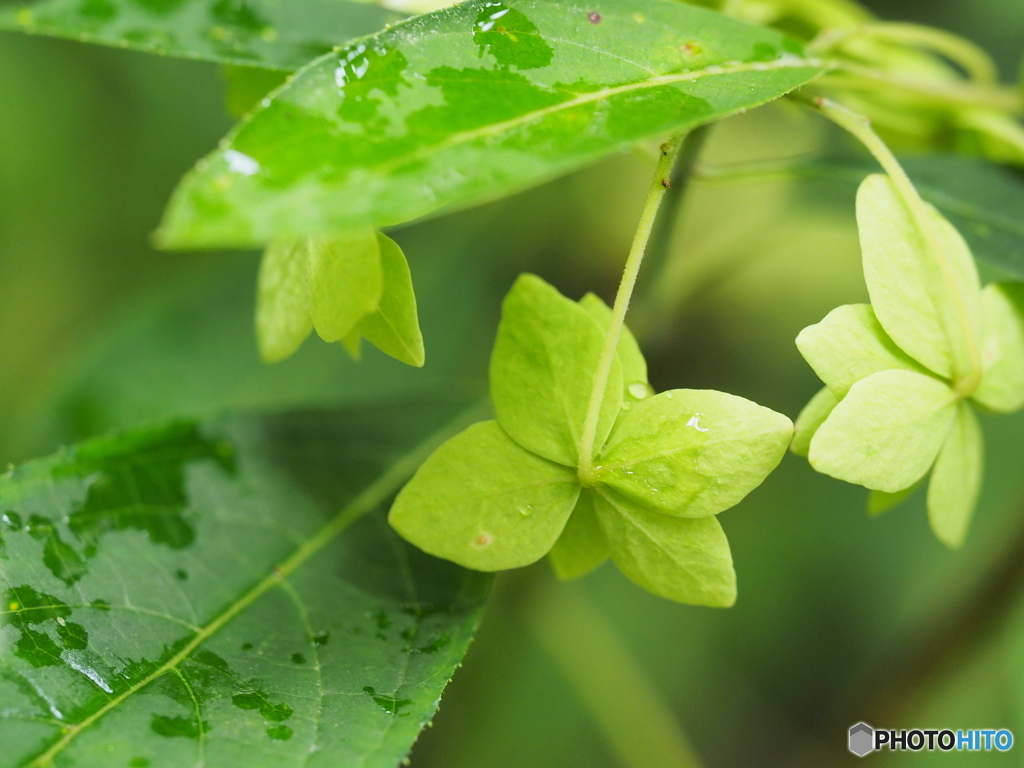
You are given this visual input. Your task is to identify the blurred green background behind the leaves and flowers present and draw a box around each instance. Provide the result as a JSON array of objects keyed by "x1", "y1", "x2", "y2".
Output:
[{"x1": 0, "y1": 0, "x2": 1024, "y2": 768}]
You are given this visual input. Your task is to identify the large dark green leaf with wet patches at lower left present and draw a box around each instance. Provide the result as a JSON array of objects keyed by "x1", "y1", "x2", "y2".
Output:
[{"x1": 0, "y1": 403, "x2": 487, "y2": 768}]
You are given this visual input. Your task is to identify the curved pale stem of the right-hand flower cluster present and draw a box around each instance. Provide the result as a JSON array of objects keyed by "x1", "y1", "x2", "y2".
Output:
[{"x1": 813, "y1": 98, "x2": 981, "y2": 397}]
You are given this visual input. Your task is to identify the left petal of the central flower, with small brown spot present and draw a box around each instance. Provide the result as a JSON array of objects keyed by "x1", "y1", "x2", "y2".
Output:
[{"x1": 388, "y1": 421, "x2": 580, "y2": 570}]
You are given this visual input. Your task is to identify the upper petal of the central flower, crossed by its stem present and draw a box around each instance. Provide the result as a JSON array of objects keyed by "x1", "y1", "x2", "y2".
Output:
[{"x1": 490, "y1": 274, "x2": 623, "y2": 467}]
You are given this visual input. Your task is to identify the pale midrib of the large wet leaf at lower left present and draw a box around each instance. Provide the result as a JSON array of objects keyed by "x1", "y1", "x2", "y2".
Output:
[{"x1": 24, "y1": 408, "x2": 479, "y2": 768}]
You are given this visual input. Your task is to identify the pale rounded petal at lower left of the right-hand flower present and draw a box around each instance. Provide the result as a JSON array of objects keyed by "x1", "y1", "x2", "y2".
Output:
[{"x1": 809, "y1": 370, "x2": 956, "y2": 494}]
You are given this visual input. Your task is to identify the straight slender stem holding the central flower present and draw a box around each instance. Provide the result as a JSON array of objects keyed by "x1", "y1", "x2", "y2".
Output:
[{"x1": 578, "y1": 134, "x2": 685, "y2": 484}]
